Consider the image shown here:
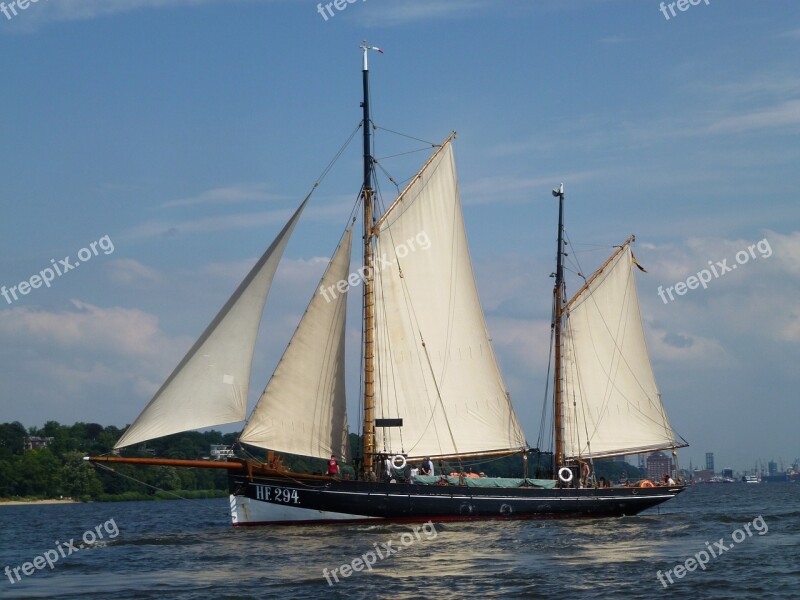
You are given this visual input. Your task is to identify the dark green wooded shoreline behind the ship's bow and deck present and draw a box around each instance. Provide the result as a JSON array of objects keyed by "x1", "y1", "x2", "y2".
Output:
[{"x1": 0, "y1": 421, "x2": 639, "y2": 501}]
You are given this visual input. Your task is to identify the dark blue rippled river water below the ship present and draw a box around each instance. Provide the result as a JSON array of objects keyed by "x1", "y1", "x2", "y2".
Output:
[{"x1": 0, "y1": 483, "x2": 800, "y2": 600}]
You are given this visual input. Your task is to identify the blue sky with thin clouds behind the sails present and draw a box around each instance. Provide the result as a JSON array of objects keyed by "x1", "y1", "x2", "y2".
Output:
[{"x1": 0, "y1": 0, "x2": 800, "y2": 470}]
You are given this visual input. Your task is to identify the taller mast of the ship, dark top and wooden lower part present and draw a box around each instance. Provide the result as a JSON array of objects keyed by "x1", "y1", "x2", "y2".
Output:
[{"x1": 360, "y1": 42, "x2": 378, "y2": 474}]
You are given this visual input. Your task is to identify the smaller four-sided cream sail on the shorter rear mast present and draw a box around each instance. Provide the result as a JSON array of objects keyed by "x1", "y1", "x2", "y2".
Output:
[{"x1": 562, "y1": 244, "x2": 684, "y2": 458}]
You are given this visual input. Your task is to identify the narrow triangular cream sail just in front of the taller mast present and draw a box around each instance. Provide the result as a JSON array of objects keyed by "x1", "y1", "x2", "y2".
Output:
[{"x1": 239, "y1": 228, "x2": 353, "y2": 458}]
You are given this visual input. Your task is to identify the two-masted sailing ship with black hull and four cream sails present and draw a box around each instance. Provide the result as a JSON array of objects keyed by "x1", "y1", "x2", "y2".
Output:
[{"x1": 88, "y1": 44, "x2": 686, "y2": 526}]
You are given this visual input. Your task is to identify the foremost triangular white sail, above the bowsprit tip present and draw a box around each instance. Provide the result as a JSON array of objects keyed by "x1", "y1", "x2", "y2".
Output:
[{"x1": 115, "y1": 199, "x2": 308, "y2": 448}]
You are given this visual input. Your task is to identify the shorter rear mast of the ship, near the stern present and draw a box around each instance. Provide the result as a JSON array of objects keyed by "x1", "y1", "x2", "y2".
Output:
[{"x1": 552, "y1": 183, "x2": 566, "y2": 472}]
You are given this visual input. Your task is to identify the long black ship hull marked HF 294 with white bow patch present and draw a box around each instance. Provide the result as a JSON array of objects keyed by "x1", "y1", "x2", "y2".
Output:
[{"x1": 229, "y1": 473, "x2": 685, "y2": 525}]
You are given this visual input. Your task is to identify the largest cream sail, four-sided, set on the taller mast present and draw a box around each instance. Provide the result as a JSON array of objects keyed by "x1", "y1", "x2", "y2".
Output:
[{"x1": 368, "y1": 140, "x2": 525, "y2": 457}]
